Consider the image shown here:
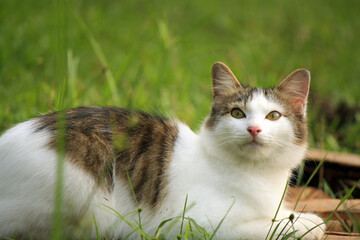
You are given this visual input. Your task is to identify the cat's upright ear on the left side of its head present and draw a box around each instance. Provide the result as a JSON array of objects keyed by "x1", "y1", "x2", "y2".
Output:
[{"x1": 212, "y1": 62, "x2": 242, "y2": 98}]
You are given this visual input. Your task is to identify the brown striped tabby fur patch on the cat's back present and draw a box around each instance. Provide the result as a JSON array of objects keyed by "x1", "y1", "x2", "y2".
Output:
[{"x1": 36, "y1": 107, "x2": 178, "y2": 206}]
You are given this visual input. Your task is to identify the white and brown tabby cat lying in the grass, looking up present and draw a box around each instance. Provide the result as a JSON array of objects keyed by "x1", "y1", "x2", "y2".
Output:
[{"x1": 0, "y1": 62, "x2": 324, "y2": 240}]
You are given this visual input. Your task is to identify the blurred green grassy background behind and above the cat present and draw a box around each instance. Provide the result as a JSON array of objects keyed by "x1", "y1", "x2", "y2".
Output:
[{"x1": 0, "y1": 0, "x2": 360, "y2": 153}]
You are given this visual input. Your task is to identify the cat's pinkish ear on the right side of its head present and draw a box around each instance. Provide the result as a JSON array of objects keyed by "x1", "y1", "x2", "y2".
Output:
[{"x1": 276, "y1": 68, "x2": 310, "y2": 114}]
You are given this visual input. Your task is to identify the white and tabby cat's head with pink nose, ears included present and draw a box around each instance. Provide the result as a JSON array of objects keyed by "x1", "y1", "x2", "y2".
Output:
[{"x1": 202, "y1": 63, "x2": 310, "y2": 167}]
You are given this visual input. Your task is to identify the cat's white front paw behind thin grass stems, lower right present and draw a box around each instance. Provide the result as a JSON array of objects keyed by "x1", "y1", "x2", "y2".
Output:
[{"x1": 293, "y1": 213, "x2": 325, "y2": 240}]
